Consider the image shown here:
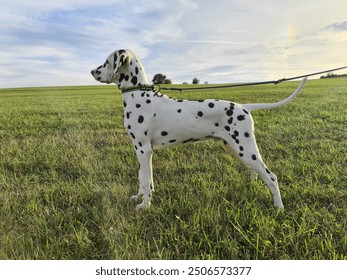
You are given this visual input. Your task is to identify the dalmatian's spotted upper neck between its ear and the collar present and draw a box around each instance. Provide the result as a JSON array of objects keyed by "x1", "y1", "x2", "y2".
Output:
[{"x1": 116, "y1": 57, "x2": 148, "y2": 90}]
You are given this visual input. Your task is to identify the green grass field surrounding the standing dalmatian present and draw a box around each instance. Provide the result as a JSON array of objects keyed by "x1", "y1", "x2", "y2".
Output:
[{"x1": 0, "y1": 78, "x2": 347, "y2": 259}]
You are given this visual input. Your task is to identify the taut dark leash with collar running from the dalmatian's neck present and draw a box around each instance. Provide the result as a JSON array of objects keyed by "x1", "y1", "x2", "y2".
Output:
[{"x1": 122, "y1": 66, "x2": 347, "y2": 93}]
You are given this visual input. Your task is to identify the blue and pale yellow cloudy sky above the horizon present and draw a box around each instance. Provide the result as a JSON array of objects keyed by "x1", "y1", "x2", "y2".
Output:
[{"x1": 0, "y1": 0, "x2": 347, "y2": 88}]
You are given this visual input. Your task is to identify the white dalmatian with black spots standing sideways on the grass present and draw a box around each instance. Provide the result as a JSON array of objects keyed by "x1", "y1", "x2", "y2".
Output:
[{"x1": 91, "y1": 50, "x2": 307, "y2": 210}]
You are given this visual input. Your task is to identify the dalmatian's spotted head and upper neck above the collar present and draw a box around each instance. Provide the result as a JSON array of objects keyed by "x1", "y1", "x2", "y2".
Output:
[{"x1": 91, "y1": 50, "x2": 148, "y2": 90}]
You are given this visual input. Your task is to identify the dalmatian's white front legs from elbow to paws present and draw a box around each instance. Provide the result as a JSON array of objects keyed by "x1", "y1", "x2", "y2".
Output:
[{"x1": 131, "y1": 149, "x2": 154, "y2": 211}]
